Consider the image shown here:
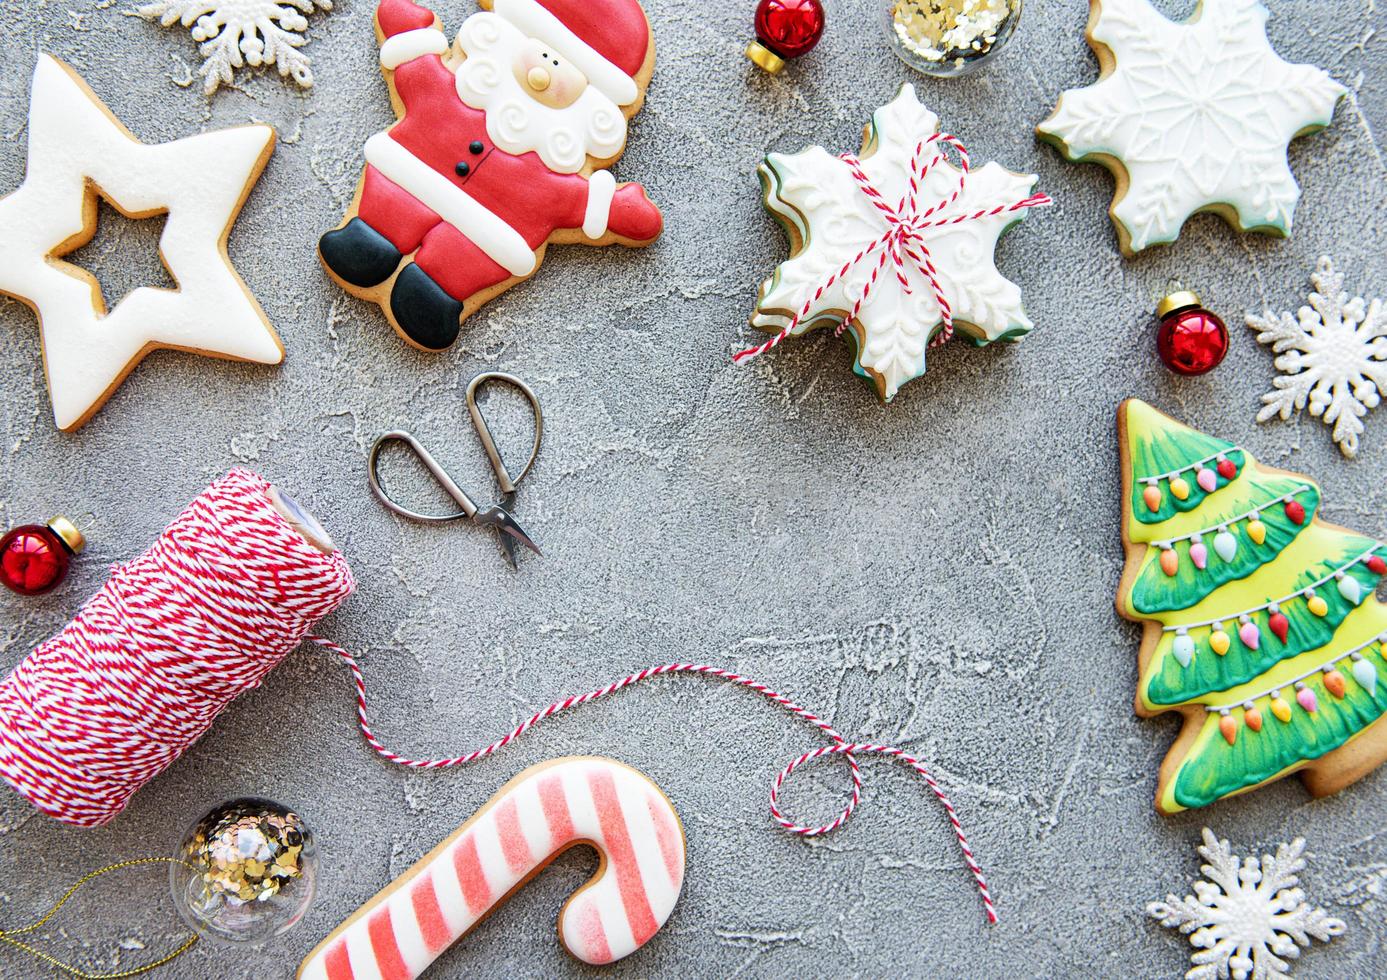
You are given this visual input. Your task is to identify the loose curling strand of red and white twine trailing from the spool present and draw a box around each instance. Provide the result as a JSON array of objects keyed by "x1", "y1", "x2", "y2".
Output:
[{"x1": 307, "y1": 636, "x2": 997, "y2": 923}]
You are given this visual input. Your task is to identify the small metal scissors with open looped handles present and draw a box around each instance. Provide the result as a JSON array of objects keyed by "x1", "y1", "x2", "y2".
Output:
[{"x1": 366, "y1": 371, "x2": 544, "y2": 568}]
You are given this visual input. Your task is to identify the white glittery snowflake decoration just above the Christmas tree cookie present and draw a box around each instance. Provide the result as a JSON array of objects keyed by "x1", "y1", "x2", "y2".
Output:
[{"x1": 1247, "y1": 256, "x2": 1387, "y2": 459}]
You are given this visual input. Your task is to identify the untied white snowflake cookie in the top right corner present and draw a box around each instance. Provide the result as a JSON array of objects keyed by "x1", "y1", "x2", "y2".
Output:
[{"x1": 1037, "y1": 0, "x2": 1347, "y2": 256}]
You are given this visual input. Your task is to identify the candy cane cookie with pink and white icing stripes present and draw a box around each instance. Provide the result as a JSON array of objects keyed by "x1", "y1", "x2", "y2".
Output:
[{"x1": 298, "y1": 757, "x2": 684, "y2": 980}]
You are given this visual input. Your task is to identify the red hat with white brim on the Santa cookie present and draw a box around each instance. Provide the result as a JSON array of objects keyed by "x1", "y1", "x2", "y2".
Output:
[{"x1": 492, "y1": 0, "x2": 651, "y2": 105}]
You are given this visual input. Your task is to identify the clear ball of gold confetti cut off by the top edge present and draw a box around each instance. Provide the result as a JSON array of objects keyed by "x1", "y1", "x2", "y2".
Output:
[{"x1": 881, "y1": 0, "x2": 1022, "y2": 78}]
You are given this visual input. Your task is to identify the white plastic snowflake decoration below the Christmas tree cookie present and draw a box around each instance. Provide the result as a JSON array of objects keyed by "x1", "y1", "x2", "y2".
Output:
[{"x1": 1146, "y1": 828, "x2": 1345, "y2": 980}]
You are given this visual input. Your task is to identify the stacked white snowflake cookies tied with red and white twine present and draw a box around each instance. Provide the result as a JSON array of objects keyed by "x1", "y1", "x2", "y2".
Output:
[{"x1": 736, "y1": 85, "x2": 1050, "y2": 402}]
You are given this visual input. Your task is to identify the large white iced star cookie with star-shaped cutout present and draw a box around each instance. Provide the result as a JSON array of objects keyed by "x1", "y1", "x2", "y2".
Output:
[{"x1": 0, "y1": 54, "x2": 284, "y2": 431}]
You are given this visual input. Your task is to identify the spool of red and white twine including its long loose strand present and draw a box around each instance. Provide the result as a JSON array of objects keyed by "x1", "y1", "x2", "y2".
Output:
[{"x1": 0, "y1": 470, "x2": 997, "y2": 922}]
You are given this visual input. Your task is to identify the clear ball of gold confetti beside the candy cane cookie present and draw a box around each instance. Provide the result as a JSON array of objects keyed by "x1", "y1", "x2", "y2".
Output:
[{"x1": 169, "y1": 797, "x2": 318, "y2": 945}]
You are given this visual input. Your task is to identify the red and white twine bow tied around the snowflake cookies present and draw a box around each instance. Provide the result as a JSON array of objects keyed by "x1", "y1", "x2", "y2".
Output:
[{"x1": 732, "y1": 133, "x2": 1053, "y2": 365}]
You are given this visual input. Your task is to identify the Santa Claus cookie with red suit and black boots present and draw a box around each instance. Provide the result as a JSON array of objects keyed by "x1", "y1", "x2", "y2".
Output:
[{"x1": 318, "y1": 0, "x2": 663, "y2": 351}]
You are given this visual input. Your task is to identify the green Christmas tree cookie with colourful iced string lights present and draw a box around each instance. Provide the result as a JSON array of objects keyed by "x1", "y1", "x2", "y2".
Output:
[{"x1": 1118, "y1": 401, "x2": 1387, "y2": 814}]
